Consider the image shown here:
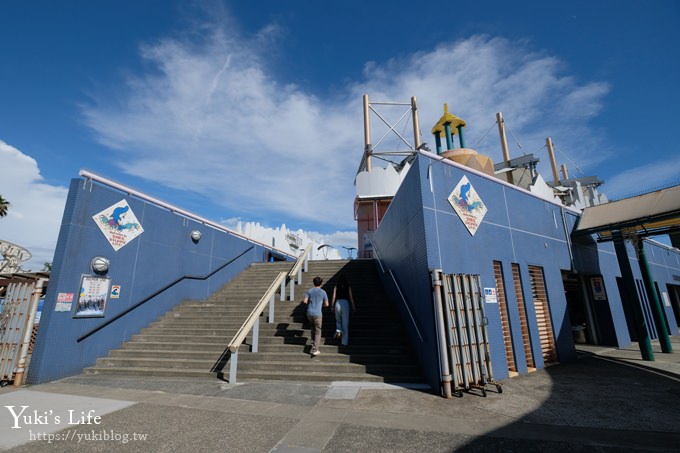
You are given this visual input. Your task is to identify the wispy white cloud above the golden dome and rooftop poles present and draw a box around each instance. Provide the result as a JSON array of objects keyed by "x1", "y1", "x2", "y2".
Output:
[{"x1": 353, "y1": 35, "x2": 609, "y2": 174}]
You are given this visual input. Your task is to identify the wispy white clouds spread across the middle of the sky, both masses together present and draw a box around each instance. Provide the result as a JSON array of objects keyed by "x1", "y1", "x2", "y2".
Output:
[{"x1": 83, "y1": 25, "x2": 608, "y2": 233}]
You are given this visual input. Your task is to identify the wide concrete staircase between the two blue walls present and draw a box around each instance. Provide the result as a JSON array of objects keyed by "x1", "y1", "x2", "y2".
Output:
[{"x1": 85, "y1": 260, "x2": 423, "y2": 383}]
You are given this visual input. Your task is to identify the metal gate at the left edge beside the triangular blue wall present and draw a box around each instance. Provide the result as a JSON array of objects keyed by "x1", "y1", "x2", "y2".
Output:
[{"x1": 0, "y1": 279, "x2": 47, "y2": 386}]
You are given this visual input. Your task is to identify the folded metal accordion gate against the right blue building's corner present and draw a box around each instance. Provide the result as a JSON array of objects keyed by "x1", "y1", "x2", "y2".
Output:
[{"x1": 441, "y1": 274, "x2": 503, "y2": 396}]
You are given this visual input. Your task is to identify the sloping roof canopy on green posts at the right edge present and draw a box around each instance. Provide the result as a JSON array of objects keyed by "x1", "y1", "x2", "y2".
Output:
[{"x1": 574, "y1": 185, "x2": 680, "y2": 240}]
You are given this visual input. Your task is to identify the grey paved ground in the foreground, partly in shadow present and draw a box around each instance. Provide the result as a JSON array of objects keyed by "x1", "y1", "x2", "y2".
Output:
[{"x1": 0, "y1": 337, "x2": 680, "y2": 453}]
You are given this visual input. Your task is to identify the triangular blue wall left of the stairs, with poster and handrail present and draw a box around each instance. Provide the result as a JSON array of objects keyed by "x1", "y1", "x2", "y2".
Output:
[{"x1": 27, "y1": 179, "x2": 284, "y2": 383}]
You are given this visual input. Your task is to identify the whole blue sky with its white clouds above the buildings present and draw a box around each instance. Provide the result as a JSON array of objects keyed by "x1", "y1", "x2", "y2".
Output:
[{"x1": 0, "y1": 0, "x2": 680, "y2": 269}]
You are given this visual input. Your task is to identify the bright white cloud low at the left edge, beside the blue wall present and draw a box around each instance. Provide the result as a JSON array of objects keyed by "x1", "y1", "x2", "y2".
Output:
[{"x1": 0, "y1": 140, "x2": 68, "y2": 271}]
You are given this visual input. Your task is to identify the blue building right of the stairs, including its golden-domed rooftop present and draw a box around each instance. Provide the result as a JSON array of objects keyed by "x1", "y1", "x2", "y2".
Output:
[{"x1": 356, "y1": 98, "x2": 680, "y2": 394}]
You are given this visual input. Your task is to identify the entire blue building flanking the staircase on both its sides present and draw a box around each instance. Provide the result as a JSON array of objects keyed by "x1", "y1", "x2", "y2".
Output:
[{"x1": 28, "y1": 99, "x2": 680, "y2": 396}]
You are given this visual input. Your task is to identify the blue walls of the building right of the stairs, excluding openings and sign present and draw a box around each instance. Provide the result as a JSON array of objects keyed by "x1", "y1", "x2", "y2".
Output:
[{"x1": 374, "y1": 154, "x2": 680, "y2": 388}]
